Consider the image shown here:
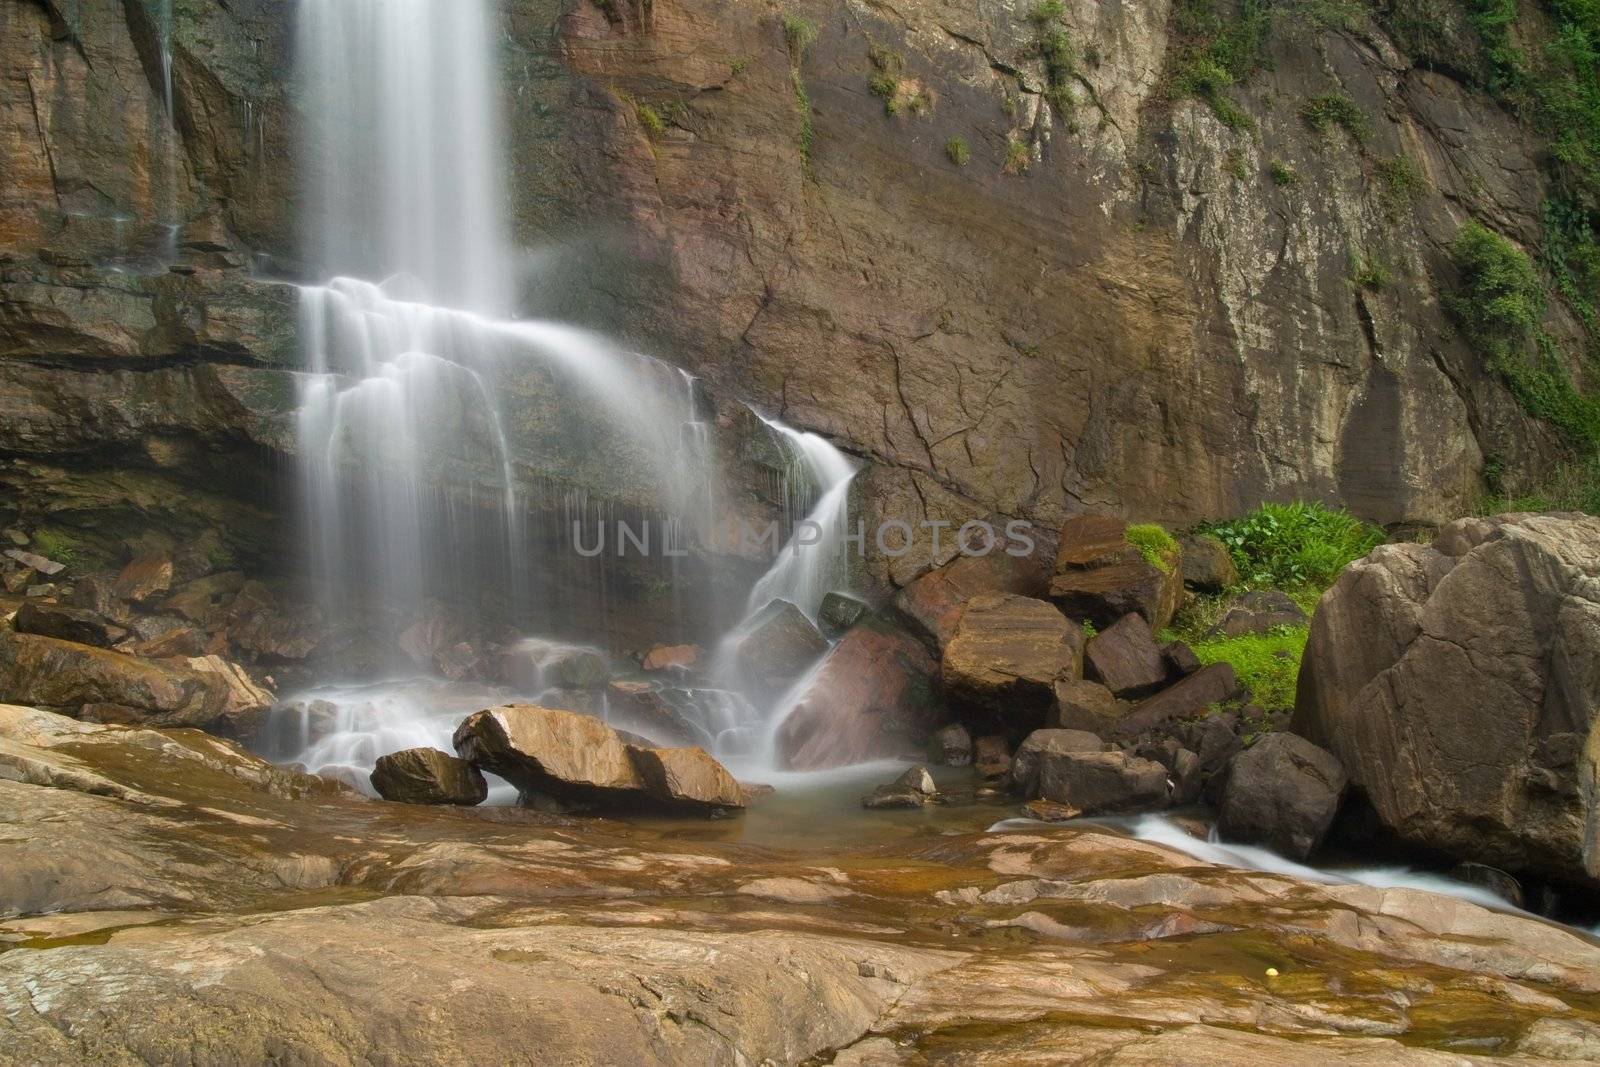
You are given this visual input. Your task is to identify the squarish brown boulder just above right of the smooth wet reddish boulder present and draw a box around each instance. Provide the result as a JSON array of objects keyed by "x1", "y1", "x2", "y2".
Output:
[{"x1": 942, "y1": 593, "x2": 1083, "y2": 721}]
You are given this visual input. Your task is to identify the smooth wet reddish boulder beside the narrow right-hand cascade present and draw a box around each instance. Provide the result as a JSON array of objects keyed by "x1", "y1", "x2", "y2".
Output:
[{"x1": 778, "y1": 616, "x2": 949, "y2": 771}]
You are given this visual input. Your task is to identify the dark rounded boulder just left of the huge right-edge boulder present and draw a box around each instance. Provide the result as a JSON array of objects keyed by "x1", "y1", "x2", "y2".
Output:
[{"x1": 1218, "y1": 734, "x2": 1347, "y2": 859}]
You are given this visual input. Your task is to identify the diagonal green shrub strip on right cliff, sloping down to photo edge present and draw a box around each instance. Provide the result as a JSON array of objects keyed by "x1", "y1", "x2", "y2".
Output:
[{"x1": 1446, "y1": 222, "x2": 1600, "y2": 456}]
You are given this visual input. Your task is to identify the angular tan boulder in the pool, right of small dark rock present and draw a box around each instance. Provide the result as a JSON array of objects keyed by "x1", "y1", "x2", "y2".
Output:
[{"x1": 451, "y1": 704, "x2": 645, "y2": 805}]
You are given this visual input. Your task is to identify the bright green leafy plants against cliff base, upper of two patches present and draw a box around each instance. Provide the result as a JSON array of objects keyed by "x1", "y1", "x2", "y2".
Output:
[{"x1": 1202, "y1": 502, "x2": 1384, "y2": 595}]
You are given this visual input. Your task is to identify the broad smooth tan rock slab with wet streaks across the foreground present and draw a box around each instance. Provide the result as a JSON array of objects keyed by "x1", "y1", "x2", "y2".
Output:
[{"x1": 0, "y1": 707, "x2": 1600, "y2": 1067}]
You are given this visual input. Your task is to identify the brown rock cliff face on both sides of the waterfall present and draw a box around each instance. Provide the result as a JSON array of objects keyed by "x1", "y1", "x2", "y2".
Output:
[{"x1": 0, "y1": 0, "x2": 1578, "y2": 591}]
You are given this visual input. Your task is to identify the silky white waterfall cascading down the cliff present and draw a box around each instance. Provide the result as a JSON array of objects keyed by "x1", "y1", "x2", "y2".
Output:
[{"x1": 281, "y1": 0, "x2": 854, "y2": 781}]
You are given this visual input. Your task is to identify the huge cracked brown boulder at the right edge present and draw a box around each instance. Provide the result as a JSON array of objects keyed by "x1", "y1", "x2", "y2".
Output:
[{"x1": 1293, "y1": 514, "x2": 1600, "y2": 885}]
